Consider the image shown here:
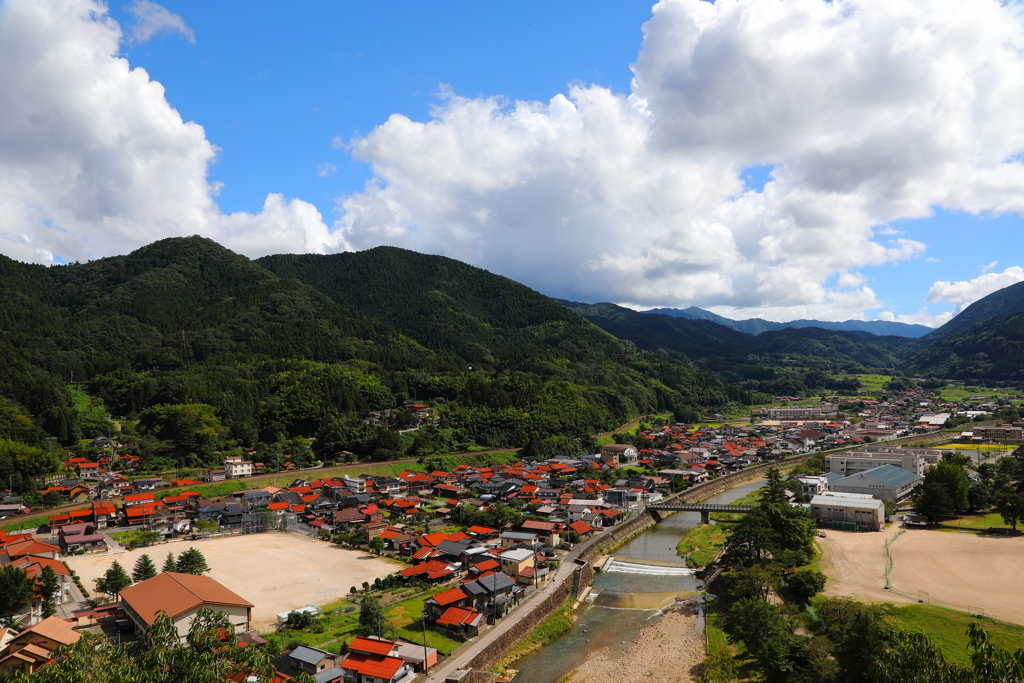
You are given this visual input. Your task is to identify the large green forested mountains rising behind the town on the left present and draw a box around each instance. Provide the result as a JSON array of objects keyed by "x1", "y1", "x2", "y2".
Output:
[{"x1": 0, "y1": 237, "x2": 749, "y2": 489}]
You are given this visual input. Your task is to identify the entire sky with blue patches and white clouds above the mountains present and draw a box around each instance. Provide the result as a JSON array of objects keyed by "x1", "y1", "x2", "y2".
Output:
[{"x1": 0, "y1": 0, "x2": 1024, "y2": 325}]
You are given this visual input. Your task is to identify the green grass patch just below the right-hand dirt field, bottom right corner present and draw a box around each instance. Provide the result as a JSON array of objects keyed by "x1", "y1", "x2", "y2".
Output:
[{"x1": 892, "y1": 605, "x2": 1024, "y2": 664}]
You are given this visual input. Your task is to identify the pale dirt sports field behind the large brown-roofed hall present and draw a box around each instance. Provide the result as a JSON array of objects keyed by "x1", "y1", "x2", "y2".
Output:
[{"x1": 68, "y1": 532, "x2": 400, "y2": 631}]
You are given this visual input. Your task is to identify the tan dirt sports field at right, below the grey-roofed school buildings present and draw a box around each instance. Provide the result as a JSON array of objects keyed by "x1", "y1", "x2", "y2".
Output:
[{"x1": 818, "y1": 527, "x2": 1024, "y2": 624}]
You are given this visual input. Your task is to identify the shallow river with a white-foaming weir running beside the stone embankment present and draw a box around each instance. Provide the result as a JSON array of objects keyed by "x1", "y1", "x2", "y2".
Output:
[{"x1": 513, "y1": 480, "x2": 764, "y2": 683}]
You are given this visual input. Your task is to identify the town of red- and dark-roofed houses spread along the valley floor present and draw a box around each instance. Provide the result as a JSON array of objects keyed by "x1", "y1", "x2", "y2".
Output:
[{"x1": 0, "y1": 393, "x2": 1024, "y2": 681}]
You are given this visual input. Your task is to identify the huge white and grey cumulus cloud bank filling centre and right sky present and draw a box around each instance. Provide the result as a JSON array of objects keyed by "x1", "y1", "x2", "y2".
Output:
[{"x1": 337, "y1": 0, "x2": 1024, "y2": 319}]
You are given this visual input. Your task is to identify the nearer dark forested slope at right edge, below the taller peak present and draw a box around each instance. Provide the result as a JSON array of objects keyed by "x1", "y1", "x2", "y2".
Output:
[{"x1": 904, "y1": 313, "x2": 1024, "y2": 381}]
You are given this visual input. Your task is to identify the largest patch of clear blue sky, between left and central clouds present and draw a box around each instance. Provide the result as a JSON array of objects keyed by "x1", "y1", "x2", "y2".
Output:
[{"x1": 111, "y1": 0, "x2": 651, "y2": 214}]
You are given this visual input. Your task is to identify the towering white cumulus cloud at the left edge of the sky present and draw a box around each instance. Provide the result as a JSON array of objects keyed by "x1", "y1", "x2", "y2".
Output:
[{"x1": 0, "y1": 0, "x2": 339, "y2": 263}]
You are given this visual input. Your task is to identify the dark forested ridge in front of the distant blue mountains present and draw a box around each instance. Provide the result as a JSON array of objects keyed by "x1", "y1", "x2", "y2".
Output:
[{"x1": 562, "y1": 301, "x2": 920, "y2": 372}]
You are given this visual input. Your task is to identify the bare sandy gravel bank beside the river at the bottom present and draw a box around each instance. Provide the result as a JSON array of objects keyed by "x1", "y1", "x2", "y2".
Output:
[{"x1": 569, "y1": 605, "x2": 705, "y2": 683}]
